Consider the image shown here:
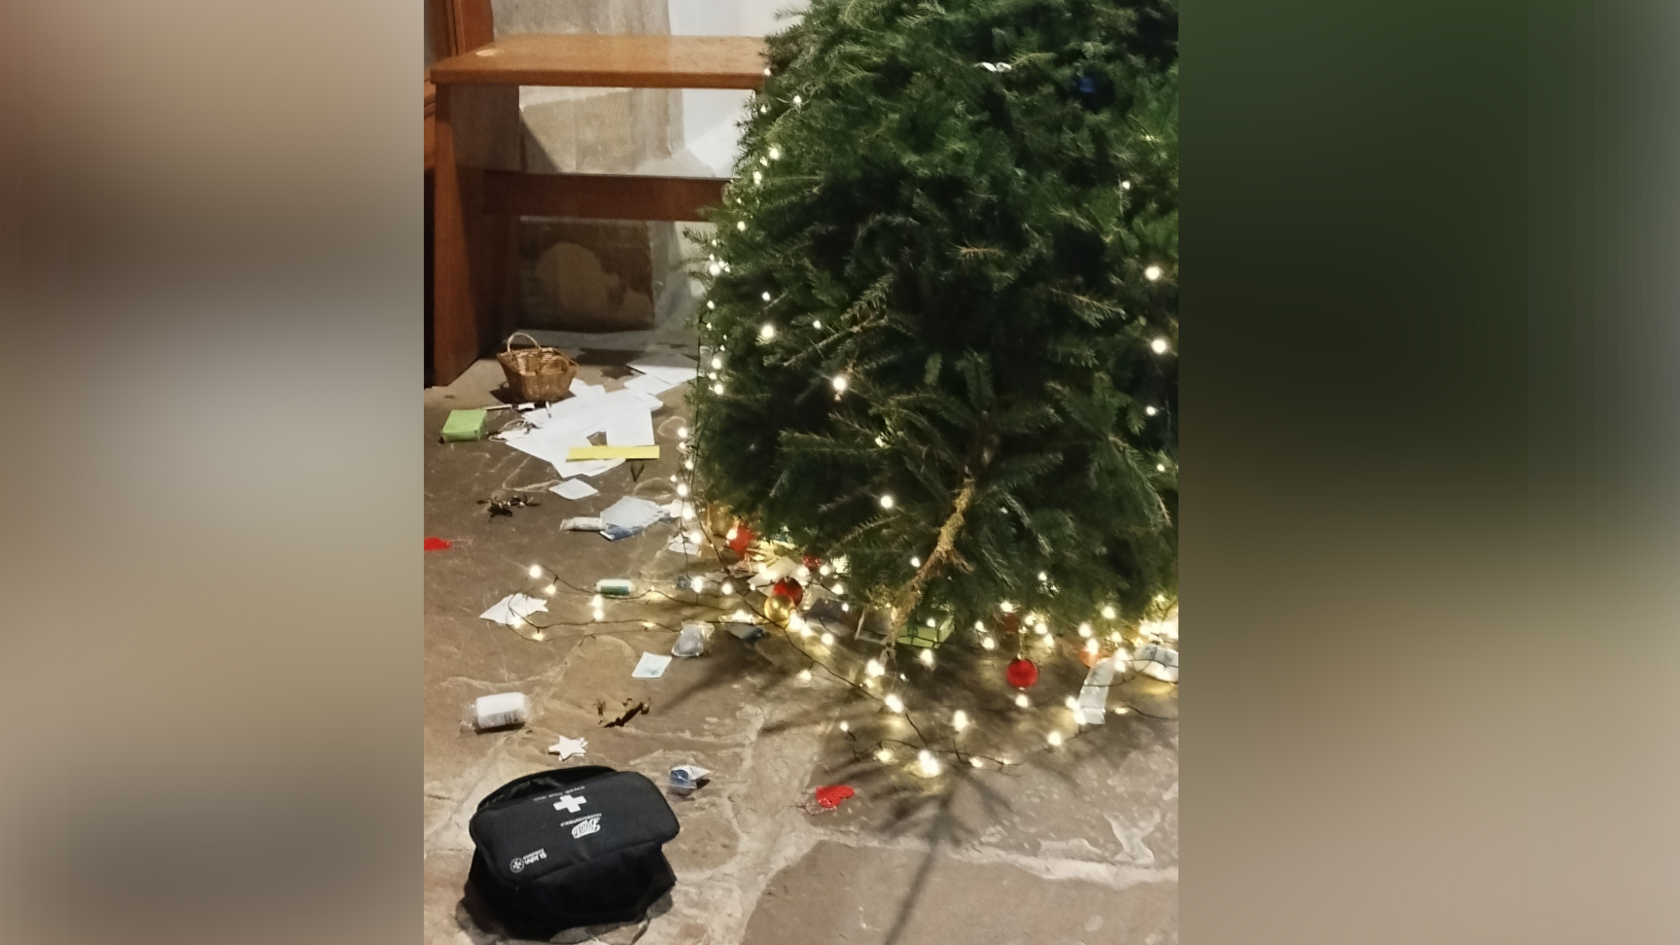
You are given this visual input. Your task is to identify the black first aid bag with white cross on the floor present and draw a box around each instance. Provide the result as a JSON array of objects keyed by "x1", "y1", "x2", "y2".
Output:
[{"x1": 467, "y1": 765, "x2": 680, "y2": 938}]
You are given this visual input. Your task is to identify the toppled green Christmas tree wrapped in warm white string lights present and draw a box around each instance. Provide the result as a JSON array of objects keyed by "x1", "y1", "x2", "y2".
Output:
[{"x1": 694, "y1": 0, "x2": 1178, "y2": 662}]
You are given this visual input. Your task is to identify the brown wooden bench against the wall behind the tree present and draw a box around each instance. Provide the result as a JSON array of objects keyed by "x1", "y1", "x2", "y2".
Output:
[{"x1": 428, "y1": 35, "x2": 764, "y2": 383}]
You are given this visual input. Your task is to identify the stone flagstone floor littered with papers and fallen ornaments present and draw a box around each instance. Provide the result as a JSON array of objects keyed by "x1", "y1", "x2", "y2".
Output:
[{"x1": 423, "y1": 350, "x2": 1178, "y2": 945}]
